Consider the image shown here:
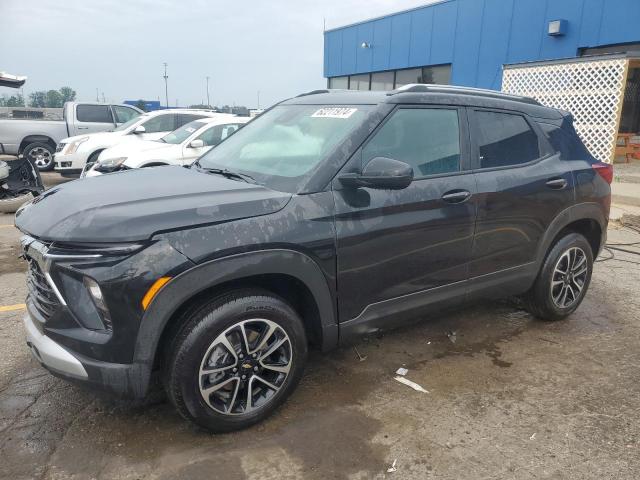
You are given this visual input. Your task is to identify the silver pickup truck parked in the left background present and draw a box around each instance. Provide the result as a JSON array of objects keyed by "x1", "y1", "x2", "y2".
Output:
[{"x1": 0, "y1": 102, "x2": 142, "y2": 170}]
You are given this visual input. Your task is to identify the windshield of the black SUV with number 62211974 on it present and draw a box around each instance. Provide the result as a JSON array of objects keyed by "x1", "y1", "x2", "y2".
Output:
[{"x1": 198, "y1": 105, "x2": 373, "y2": 191}]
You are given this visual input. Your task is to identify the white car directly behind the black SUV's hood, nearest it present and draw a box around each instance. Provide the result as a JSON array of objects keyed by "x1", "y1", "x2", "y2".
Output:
[{"x1": 82, "y1": 114, "x2": 251, "y2": 177}]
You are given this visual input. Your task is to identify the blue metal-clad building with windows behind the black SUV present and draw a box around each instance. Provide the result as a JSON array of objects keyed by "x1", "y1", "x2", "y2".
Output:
[{"x1": 324, "y1": 0, "x2": 640, "y2": 90}]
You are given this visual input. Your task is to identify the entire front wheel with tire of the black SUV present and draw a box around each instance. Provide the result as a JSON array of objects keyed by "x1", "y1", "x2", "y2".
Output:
[{"x1": 163, "y1": 290, "x2": 307, "y2": 433}]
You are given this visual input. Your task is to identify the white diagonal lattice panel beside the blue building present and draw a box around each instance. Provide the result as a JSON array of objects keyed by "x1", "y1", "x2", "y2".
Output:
[{"x1": 502, "y1": 59, "x2": 627, "y2": 162}]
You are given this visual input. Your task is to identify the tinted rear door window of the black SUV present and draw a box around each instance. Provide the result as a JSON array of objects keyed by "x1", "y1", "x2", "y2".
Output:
[{"x1": 475, "y1": 111, "x2": 541, "y2": 168}]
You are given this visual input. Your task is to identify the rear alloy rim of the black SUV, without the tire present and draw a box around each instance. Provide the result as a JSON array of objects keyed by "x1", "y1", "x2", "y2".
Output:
[{"x1": 551, "y1": 247, "x2": 589, "y2": 308}]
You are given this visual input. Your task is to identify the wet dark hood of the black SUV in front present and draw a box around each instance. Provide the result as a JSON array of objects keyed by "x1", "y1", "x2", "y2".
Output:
[{"x1": 15, "y1": 167, "x2": 291, "y2": 243}]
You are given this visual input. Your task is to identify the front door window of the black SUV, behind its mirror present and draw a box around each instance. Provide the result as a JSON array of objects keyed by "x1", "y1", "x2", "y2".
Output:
[{"x1": 362, "y1": 108, "x2": 460, "y2": 178}]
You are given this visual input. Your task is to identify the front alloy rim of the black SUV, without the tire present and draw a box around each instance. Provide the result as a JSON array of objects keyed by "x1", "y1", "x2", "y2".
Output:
[{"x1": 198, "y1": 318, "x2": 292, "y2": 415}]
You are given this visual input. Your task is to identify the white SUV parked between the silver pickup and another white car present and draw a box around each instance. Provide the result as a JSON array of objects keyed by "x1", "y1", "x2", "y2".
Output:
[{"x1": 53, "y1": 108, "x2": 221, "y2": 175}]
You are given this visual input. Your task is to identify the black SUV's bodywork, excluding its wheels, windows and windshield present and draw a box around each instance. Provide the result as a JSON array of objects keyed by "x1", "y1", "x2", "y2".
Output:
[{"x1": 16, "y1": 87, "x2": 610, "y2": 396}]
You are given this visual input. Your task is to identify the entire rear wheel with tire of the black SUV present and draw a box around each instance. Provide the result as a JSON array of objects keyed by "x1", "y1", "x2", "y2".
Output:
[{"x1": 523, "y1": 233, "x2": 593, "y2": 321}]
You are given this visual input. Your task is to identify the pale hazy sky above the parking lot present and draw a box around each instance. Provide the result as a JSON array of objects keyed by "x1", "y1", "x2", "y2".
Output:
[{"x1": 0, "y1": 0, "x2": 431, "y2": 107}]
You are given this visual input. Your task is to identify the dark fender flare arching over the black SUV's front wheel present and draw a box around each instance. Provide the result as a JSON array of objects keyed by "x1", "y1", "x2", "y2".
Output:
[{"x1": 134, "y1": 249, "x2": 338, "y2": 374}]
